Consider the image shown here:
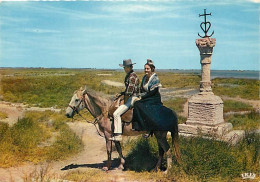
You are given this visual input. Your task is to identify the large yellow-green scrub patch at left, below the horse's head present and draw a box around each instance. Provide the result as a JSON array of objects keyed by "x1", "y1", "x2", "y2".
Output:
[{"x1": 0, "y1": 111, "x2": 82, "y2": 167}]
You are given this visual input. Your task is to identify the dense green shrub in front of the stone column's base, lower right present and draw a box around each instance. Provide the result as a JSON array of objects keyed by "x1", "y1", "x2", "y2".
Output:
[{"x1": 180, "y1": 138, "x2": 242, "y2": 181}]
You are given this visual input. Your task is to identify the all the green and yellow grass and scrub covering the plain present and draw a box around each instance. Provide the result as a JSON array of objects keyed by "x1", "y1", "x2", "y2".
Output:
[{"x1": 0, "y1": 69, "x2": 260, "y2": 181}]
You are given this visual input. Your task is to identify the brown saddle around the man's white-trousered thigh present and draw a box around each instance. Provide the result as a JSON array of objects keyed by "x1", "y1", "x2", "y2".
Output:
[{"x1": 108, "y1": 95, "x2": 133, "y2": 123}]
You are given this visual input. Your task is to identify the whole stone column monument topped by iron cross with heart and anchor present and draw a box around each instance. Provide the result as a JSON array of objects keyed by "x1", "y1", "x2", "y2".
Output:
[{"x1": 179, "y1": 9, "x2": 244, "y2": 144}]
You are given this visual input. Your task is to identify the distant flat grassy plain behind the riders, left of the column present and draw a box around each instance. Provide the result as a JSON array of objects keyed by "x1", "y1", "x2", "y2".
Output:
[{"x1": 0, "y1": 69, "x2": 200, "y2": 108}]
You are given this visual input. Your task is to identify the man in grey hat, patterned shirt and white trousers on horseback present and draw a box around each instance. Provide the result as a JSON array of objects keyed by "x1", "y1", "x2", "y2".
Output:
[{"x1": 110, "y1": 59, "x2": 139, "y2": 141}]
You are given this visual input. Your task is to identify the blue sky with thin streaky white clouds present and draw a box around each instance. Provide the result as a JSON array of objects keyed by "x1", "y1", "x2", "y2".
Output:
[{"x1": 0, "y1": 0, "x2": 260, "y2": 70}]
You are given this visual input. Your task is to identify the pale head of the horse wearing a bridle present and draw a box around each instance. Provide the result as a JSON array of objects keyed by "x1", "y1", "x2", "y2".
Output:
[{"x1": 65, "y1": 89, "x2": 85, "y2": 118}]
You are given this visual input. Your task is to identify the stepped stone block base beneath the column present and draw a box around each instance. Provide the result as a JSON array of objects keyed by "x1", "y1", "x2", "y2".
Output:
[{"x1": 178, "y1": 92, "x2": 245, "y2": 145}]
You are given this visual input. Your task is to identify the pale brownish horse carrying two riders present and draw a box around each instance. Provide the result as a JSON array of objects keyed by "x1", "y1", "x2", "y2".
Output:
[{"x1": 66, "y1": 89, "x2": 180, "y2": 173}]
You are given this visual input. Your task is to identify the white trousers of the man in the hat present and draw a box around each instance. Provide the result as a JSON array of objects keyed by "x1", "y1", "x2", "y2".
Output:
[{"x1": 113, "y1": 96, "x2": 138, "y2": 134}]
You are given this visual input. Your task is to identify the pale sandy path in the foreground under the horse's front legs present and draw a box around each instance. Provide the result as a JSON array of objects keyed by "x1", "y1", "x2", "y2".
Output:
[{"x1": 0, "y1": 122, "x2": 125, "y2": 182}]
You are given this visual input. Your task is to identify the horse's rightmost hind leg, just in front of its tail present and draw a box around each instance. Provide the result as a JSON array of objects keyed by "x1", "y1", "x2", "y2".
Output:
[{"x1": 154, "y1": 131, "x2": 172, "y2": 172}]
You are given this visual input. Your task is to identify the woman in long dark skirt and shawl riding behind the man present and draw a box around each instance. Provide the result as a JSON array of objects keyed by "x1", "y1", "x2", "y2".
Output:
[{"x1": 132, "y1": 59, "x2": 177, "y2": 136}]
